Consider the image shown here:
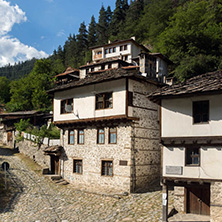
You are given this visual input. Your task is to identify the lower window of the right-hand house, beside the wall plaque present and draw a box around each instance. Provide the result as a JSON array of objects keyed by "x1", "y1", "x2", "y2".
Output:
[{"x1": 185, "y1": 147, "x2": 200, "y2": 166}]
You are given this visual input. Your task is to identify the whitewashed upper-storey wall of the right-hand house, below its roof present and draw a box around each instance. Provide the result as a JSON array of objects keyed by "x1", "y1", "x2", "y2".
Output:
[{"x1": 161, "y1": 95, "x2": 222, "y2": 137}]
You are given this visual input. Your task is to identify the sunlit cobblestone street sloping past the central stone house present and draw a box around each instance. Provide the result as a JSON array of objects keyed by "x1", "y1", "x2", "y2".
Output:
[{"x1": 0, "y1": 148, "x2": 168, "y2": 222}]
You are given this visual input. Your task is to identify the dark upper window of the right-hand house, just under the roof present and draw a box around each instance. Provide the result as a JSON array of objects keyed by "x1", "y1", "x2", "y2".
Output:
[{"x1": 193, "y1": 101, "x2": 209, "y2": 123}]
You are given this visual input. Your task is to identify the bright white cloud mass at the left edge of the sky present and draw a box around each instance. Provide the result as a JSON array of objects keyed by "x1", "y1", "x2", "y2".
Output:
[{"x1": 0, "y1": 0, "x2": 48, "y2": 66}]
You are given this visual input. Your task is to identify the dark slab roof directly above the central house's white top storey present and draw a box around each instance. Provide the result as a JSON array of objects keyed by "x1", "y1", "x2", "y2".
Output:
[{"x1": 47, "y1": 68, "x2": 160, "y2": 93}]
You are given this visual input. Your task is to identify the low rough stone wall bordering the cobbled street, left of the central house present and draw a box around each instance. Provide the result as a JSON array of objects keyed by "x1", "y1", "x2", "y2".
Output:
[{"x1": 16, "y1": 139, "x2": 50, "y2": 168}]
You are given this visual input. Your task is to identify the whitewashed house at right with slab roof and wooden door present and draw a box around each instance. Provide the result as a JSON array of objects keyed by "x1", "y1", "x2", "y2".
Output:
[{"x1": 149, "y1": 71, "x2": 222, "y2": 222}]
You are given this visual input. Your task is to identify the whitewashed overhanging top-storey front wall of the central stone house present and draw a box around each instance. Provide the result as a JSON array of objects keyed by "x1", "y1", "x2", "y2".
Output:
[{"x1": 53, "y1": 79, "x2": 126, "y2": 121}]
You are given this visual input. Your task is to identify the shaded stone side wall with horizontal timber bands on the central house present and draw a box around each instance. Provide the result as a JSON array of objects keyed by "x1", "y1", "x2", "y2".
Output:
[{"x1": 129, "y1": 80, "x2": 161, "y2": 190}]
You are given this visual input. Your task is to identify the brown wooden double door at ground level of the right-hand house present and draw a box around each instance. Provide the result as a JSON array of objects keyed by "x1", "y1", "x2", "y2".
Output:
[{"x1": 186, "y1": 185, "x2": 210, "y2": 215}]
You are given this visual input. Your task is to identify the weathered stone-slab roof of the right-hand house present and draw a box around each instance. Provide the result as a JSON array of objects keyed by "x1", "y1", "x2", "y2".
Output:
[{"x1": 148, "y1": 70, "x2": 222, "y2": 102}]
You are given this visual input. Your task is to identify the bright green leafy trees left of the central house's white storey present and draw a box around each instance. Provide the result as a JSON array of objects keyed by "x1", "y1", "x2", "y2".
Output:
[{"x1": 6, "y1": 59, "x2": 54, "y2": 112}]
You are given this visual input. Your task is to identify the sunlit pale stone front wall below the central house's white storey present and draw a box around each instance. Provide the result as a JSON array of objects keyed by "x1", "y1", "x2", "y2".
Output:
[{"x1": 60, "y1": 123, "x2": 131, "y2": 192}]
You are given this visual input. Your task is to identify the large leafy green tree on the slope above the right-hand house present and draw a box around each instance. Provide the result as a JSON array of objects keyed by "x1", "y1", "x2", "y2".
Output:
[{"x1": 157, "y1": 0, "x2": 222, "y2": 80}]
